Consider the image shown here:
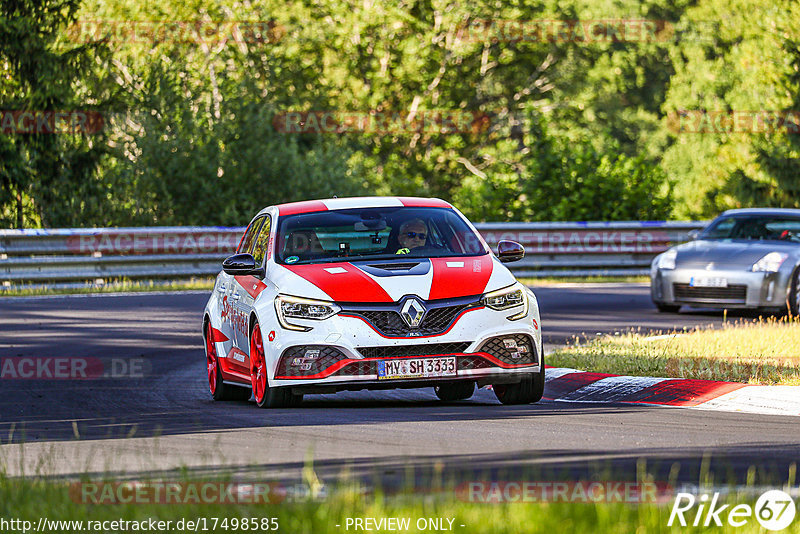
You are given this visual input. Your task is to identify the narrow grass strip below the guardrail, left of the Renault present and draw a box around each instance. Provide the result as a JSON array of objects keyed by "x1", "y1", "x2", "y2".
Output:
[{"x1": 0, "y1": 278, "x2": 214, "y2": 297}]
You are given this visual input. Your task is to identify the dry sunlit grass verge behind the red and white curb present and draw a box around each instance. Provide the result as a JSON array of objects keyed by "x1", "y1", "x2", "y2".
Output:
[{"x1": 548, "y1": 317, "x2": 800, "y2": 386}]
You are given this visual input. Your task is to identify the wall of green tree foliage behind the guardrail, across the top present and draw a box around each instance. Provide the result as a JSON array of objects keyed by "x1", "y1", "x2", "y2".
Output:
[{"x1": 0, "y1": 0, "x2": 800, "y2": 226}]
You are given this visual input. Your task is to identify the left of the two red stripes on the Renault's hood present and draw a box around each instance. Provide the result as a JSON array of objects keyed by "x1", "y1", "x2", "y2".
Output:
[{"x1": 284, "y1": 262, "x2": 394, "y2": 302}]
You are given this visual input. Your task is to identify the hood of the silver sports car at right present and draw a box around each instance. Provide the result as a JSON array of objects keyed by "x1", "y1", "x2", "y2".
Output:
[{"x1": 675, "y1": 239, "x2": 798, "y2": 269}]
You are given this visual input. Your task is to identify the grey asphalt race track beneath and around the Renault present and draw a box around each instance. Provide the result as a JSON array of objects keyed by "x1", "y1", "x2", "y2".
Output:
[{"x1": 0, "y1": 284, "x2": 800, "y2": 487}]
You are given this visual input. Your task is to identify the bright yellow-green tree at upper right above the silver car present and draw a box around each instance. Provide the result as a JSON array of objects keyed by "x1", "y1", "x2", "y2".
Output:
[{"x1": 663, "y1": 0, "x2": 800, "y2": 218}]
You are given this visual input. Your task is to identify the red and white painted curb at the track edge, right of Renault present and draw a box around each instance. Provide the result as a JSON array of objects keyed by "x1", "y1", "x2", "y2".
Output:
[{"x1": 544, "y1": 367, "x2": 800, "y2": 415}]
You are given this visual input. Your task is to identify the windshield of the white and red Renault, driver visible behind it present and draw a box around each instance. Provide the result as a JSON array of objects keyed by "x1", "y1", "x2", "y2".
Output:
[{"x1": 275, "y1": 207, "x2": 487, "y2": 265}]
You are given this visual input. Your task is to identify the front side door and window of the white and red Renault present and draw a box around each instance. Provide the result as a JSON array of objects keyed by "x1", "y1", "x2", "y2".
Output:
[{"x1": 233, "y1": 215, "x2": 272, "y2": 372}]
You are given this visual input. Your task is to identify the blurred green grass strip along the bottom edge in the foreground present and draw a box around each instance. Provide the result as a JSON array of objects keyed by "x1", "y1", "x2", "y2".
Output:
[{"x1": 0, "y1": 477, "x2": 800, "y2": 534}]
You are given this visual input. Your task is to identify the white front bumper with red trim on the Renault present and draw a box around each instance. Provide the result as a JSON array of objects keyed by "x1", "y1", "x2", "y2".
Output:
[{"x1": 262, "y1": 298, "x2": 542, "y2": 390}]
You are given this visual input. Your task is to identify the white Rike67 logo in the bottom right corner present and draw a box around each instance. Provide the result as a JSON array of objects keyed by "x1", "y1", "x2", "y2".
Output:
[{"x1": 667, "y1": 490, "x2": 797, "y2": 531}]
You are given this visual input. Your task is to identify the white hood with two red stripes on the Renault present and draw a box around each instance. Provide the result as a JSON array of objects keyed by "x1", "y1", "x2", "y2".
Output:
[{"x1": 271, "y1": 254, "x2": 515, "y2": 303}]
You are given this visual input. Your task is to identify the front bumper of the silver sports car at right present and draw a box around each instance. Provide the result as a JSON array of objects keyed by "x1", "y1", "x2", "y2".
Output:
[{"x1": 650, "y1": 267, "x2": 789, "y2": 309}]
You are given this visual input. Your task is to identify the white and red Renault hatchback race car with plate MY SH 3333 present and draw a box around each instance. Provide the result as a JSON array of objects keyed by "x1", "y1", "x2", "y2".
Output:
[{"x1": 203, "y1": 197, "x2": 545, "y2": 407}]
